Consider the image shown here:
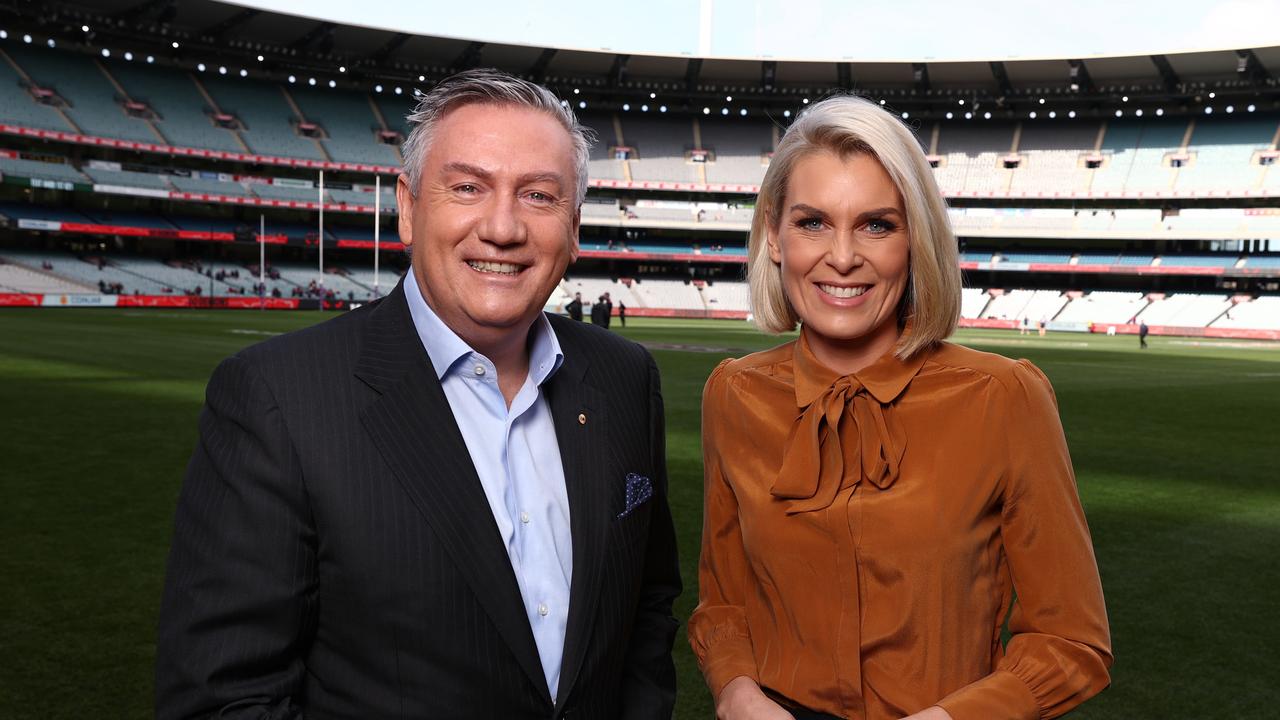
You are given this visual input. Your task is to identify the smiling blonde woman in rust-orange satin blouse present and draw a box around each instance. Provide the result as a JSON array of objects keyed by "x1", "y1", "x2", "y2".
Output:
[{"x1": 689, "y1": 97, "x2": 1111, "y2": 720}]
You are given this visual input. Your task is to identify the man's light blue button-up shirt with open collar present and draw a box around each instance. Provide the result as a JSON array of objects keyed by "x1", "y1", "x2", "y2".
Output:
[{"x1": 404, "y1": 270, "x2": 573, "y2": 697}]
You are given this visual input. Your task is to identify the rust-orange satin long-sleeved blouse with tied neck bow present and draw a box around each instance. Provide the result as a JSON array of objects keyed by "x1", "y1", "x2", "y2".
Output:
[{"x1": 689, "y1": 333, "x2": 1111, "y2": 720}]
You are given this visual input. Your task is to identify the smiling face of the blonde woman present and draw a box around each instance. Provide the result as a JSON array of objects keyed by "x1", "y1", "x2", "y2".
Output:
[{"x1": 768, "y1": 151, "x2": 910, "y2": 373}]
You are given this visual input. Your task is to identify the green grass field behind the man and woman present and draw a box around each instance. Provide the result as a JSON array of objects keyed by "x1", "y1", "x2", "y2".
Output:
[{"x1": 0, "y1": 310, "x2": 1280, "y2": 720}]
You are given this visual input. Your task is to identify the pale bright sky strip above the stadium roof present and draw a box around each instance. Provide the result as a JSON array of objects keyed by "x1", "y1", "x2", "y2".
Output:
[{"x1": 233, "y1": 0, "x2": 1280, "y2": 61}]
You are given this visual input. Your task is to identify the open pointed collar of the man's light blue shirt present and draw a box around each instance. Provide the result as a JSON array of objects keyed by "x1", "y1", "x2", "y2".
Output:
[{"x1": 404, "y1": 268, "x2": 564, "y2": 386}]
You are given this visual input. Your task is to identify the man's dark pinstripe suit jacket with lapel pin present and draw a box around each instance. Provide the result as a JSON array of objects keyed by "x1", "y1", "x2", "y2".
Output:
[{"x1": 156, "y1": 279, "x2": 680, "y2": 719}]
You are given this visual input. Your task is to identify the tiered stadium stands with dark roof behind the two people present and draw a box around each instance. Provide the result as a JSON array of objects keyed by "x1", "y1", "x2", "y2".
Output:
[{"x1": 0, "y1": 0, "x2": 1280, "y2": 338}]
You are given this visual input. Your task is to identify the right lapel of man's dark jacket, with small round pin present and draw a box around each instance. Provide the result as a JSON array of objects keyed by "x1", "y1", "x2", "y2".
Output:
[{"x1": 544, "y1": 333, "x2": 613, "y2": 710}]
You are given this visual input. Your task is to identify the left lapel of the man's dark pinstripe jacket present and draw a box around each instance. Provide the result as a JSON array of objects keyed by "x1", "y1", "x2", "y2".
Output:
[{"x1": 356, "y1": 283, "x2": 550, "y2": 702}]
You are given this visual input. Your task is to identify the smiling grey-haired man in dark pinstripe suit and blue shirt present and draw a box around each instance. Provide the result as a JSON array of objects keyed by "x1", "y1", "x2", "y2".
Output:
[{"x1": 156, "y1": 70, "x2": 680, "y2": 720}]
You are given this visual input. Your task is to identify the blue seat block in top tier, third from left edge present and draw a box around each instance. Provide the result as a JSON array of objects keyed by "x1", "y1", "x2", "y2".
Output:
[{"x1": 106, "y1": 59, "x2": 244, "y2": 152}]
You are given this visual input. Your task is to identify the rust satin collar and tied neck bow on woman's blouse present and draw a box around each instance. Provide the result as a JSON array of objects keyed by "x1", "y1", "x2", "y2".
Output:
[{"x1": 771, "y1": 338, "x2": 923, "y2": 515}]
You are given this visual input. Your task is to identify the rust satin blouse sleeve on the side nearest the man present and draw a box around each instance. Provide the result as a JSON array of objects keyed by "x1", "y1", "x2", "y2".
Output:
[{"x1": 689, "y1": 360, "x2": 758, "y2": 697}]
